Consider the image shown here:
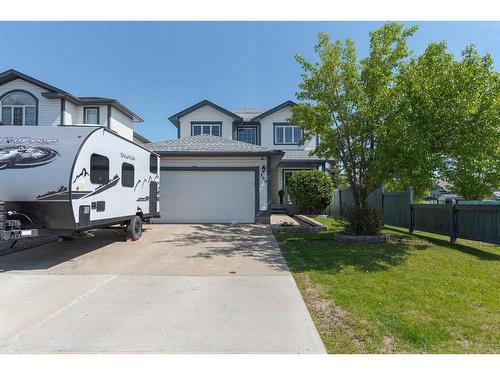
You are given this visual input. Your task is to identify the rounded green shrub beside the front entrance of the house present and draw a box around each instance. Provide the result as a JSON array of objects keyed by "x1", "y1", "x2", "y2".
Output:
[{"x1": 287, "y1": 170, "x2": 333, "y2": 214}]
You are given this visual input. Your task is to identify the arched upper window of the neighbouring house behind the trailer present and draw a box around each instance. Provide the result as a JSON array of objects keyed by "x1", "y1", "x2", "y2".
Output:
[{"x1": 0, "y1": 91, "x2": 37, "y2": 126}]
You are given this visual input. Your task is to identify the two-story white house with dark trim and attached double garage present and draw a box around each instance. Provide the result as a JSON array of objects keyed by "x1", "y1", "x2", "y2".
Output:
[{"x1": 147, "y1": 100, "x2": 325, "y2": 223}]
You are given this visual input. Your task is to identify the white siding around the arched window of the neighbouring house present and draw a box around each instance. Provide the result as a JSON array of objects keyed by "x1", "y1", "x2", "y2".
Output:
[{"x1": 0, "y1": 78, "x2": 61, "y2": 126}]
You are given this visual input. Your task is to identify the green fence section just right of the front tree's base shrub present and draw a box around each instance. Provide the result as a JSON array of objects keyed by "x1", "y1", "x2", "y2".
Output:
[{"x1": 383, "y1": 190, "x2": 413, "y2": 228}]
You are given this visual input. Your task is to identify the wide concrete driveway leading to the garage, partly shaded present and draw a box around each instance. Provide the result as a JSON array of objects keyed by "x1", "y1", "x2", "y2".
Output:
[{"x1": 0, "y1": 225, "x2": 325, "y2": 353}]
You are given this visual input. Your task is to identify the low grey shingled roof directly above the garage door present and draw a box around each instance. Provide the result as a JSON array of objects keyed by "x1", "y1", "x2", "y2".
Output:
[{"x1": 146, "y1": 134, "x2": 283, "y2": 156}]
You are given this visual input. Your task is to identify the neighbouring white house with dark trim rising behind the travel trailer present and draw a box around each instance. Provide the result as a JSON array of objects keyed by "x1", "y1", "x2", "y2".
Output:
[{"x1": 0, "y1": 69, "x2": 142, "y2": 140}]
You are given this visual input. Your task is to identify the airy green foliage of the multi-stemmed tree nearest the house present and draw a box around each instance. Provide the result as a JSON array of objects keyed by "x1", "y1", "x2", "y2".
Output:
[{"x1": 291, "y1": 23, "x2": 416, "y2": 207}]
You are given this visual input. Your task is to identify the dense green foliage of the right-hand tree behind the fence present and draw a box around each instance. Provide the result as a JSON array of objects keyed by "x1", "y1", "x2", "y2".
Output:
[{"x1": 385, "y1": 42, "x2": 500, "y2": 199}]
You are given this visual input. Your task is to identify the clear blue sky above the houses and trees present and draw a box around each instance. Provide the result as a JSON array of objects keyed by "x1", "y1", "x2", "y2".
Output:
[{"x1": 0, "y1": 22, "x2": 500, "y2": 140}]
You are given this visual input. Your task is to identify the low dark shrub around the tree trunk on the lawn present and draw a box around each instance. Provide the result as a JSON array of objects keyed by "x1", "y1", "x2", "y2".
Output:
[{"x1": 345, "y1": 206, "x2": 384, "y2": 236}]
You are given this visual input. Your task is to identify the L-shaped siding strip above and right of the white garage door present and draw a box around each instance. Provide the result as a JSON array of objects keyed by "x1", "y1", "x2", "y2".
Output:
[{"x1": 161, "y1": 157, "x2": 267, "y2": 211}]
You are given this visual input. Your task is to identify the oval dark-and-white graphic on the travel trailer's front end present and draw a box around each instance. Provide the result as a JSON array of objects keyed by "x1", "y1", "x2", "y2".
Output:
[{"x1": 0, "y1": 145, "x2": 59, "y2": 170}]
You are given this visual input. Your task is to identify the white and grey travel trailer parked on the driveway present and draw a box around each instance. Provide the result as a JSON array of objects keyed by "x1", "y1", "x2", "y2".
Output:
[{"x1": 0, "y1": 126, "x2": 160, "y2": 240}]
